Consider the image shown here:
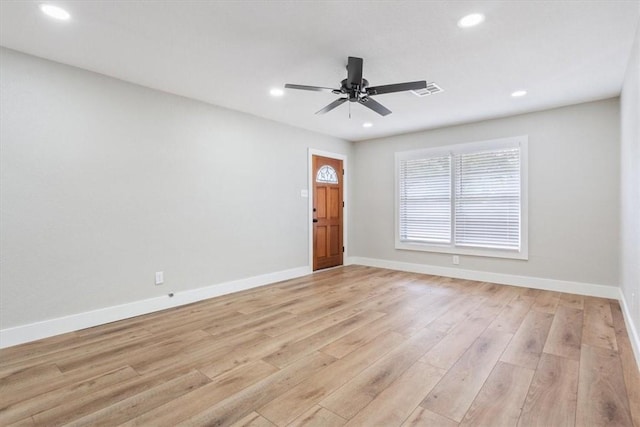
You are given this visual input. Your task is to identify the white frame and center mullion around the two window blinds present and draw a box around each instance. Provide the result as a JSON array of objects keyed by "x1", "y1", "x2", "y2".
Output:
[{"x1": 394, "y1": 135, "x2": 529, "y2": 260}]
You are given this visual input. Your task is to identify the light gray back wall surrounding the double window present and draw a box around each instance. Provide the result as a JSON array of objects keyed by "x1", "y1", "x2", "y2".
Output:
[{"x1": 351, "y1": 98, "x2": 620, "y2": 286}]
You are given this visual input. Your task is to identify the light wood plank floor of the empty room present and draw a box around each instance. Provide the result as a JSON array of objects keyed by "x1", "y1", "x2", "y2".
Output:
[{"x1": 0, "y1": 266, "x2": 640, "y2": 427}]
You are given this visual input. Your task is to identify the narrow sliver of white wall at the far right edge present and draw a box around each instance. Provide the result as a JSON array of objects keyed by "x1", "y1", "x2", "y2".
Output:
[{"x1": 620, "y1": 22, "x2": 640, "y2": 344}]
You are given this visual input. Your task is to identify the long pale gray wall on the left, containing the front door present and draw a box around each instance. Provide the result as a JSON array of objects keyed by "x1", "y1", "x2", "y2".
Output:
[{"x1": 0, "y1": 49, "x2": 351, "y2": 329}]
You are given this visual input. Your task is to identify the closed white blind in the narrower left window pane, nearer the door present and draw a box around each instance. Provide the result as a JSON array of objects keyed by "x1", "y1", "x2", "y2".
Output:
[{"x1": 399, "y1": 155, "x2": 451, "y2": 243}]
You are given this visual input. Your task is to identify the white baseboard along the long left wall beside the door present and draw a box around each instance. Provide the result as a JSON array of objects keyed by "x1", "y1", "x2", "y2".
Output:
[{"x1": 0, "y1": 266, "x2": 312, "y2": 348}]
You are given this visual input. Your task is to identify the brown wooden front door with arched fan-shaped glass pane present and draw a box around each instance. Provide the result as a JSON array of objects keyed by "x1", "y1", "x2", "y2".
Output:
[{"x1": 312, "y1": 155, "x2": 344, "y2": 271}]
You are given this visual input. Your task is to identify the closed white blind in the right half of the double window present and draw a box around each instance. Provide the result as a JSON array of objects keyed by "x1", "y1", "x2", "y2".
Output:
[{"x1": 454, "y1": 148, "x2": 520, "y2": 250}]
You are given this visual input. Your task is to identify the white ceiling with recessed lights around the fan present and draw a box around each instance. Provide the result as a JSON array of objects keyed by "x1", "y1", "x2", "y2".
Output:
[{"x1": 0, "y1": 0, "x2": 640, "y2": 141}]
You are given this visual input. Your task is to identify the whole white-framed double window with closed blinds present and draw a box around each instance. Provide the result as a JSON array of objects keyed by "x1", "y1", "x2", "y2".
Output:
[{"x1": 396, "y1": 136, "x2": 528, "y2": 259}]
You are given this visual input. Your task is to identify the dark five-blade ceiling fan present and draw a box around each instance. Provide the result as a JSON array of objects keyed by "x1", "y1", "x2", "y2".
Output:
[{"x1": 284, "y1": 56, "x2": 427, "y2": 116}]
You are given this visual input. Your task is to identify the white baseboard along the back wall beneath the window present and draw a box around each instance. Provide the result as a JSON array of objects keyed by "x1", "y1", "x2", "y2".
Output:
[{"x1": 349, "y1": 257, "x2": 620, "y2": 300}]
